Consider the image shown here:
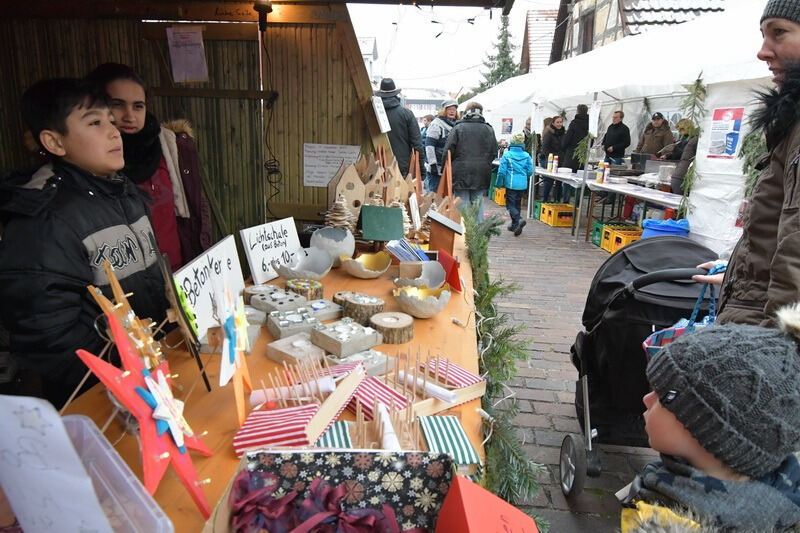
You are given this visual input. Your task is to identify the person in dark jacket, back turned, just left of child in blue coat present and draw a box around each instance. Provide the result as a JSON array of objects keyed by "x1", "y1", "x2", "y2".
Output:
[{"x1": 444, "y1": 102, "x2": 497, "y2": 221}]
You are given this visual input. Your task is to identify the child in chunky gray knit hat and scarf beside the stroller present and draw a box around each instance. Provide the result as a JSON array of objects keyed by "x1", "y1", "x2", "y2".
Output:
[{"x1": 623, "y1": 304, "x2": 800, "y2": 532}]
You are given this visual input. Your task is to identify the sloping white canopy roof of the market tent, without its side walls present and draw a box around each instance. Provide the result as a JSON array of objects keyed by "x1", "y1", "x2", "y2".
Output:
[{"x1": 470, "y1": 0, "x2": 770, "y2": 110}]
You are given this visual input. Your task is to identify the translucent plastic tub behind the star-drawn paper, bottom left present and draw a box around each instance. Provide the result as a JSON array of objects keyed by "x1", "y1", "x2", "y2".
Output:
[{"x1": 63, "y1": 415, "x2": 174, "y2": 533}]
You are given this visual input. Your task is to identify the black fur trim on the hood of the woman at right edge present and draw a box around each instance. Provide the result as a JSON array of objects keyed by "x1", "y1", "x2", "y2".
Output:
[{"x1": 752, "y1": 63, "x2": 800, "y2": 149}]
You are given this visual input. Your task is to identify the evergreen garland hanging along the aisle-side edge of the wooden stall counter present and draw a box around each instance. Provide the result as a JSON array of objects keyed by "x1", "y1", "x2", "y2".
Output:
[{"x1": 463, "y1": 203, "x2": 547, "y2": 531}]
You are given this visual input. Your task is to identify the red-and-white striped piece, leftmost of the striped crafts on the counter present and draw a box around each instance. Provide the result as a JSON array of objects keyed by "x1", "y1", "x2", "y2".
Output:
[{"x1": 233, "y1": 403, "x2": 319, "y2": 457}]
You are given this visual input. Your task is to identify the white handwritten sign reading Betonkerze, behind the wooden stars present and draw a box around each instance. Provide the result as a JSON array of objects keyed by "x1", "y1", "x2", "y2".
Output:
[{"x1": 174, "y1": 235, "x2": 244, "y2": 340}]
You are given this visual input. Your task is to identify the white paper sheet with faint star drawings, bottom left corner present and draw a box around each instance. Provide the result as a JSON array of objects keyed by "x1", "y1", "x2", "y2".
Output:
[{"x1": 0, "y1": 396, "x2": 112, "y2": 532}]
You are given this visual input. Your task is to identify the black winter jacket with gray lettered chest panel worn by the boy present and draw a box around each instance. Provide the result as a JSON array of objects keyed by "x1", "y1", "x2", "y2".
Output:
[{"x1": 0, "y1": 161, "x2": 167, "y2": 401}]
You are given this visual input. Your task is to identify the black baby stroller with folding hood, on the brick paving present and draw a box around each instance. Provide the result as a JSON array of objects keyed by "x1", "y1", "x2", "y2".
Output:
[{"x1": 559, "y1": 237, "x2": 717, "y2": 496}]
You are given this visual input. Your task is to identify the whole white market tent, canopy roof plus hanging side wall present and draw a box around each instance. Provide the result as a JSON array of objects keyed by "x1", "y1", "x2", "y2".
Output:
[{"x1": 471, "y1": 0, "x2": 770, "y2": 255}]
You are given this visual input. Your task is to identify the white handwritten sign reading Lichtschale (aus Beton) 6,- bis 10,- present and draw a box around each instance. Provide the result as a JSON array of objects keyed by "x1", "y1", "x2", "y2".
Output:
[{"x1": 239, "y1": 217, "x2": 300, "y2": 285}]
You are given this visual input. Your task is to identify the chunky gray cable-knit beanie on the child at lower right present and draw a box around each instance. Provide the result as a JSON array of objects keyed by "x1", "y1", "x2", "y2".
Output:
[{"x1": 647, "y1": 314, "x2": 800, "y2": 478}]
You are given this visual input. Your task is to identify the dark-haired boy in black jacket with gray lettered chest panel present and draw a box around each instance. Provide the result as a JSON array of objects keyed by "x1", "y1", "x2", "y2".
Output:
[{"x1": 0, "y1": 78, "x2": 167, "y2": 407}]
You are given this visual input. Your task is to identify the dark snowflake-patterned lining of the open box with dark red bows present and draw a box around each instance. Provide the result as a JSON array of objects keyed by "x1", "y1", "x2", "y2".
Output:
[{"x1": 207, "y1": 449, "x2": 453, "y2": 532}]
